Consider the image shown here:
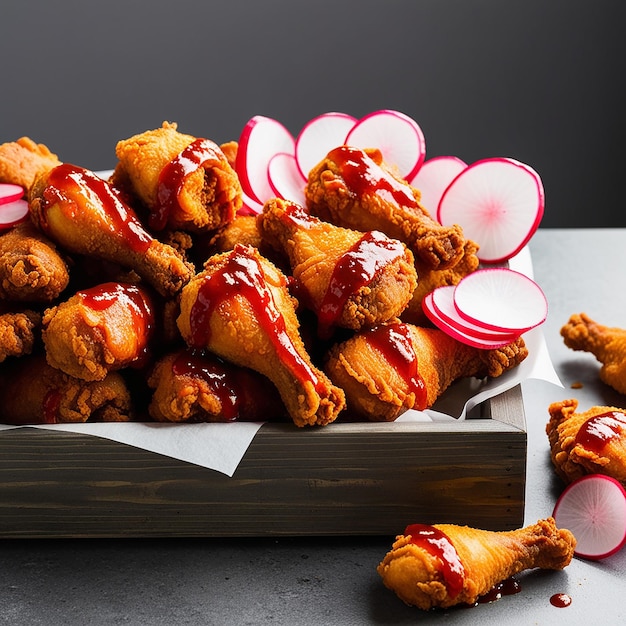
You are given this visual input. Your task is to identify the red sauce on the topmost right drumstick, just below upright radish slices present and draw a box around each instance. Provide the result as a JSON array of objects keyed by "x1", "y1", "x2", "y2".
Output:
[{"x1": 328, "y1": 146, "x2": 417, "y2": 208}]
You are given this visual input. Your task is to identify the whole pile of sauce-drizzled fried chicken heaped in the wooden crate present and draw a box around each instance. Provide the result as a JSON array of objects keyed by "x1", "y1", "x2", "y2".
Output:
[{"x1": 0, "y1": 122, "x2": 527, "y2": 426}]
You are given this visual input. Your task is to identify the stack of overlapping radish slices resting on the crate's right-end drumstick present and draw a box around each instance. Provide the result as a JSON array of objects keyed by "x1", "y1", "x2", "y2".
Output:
[{"x1": 422, "y1": 268, "x2": 548, "y2": 350}]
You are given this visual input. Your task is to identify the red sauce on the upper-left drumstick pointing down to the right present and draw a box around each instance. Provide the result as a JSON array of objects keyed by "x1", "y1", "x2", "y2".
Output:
[{"x1": 42, "y1": 163, "x2": 152, "y2": 252}]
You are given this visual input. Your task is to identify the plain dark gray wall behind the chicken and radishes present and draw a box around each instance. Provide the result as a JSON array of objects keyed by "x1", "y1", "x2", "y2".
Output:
[{"x1": 0, "y1": 0, "x2": 626, "y2": 227}]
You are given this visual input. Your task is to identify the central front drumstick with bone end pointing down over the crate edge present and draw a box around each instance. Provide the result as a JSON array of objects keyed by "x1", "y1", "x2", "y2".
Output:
[{"x1": 178, "y1": 245, "x2": 344, "y2": 426}]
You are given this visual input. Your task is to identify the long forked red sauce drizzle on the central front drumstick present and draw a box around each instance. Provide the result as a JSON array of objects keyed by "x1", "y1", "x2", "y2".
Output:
[{"x1": 189, "y1": 244, "x2": 321, "y2": 391}]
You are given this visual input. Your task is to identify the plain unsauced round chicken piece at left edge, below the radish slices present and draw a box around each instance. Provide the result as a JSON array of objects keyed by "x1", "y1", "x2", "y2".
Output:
[{"x1": 0, "y1": 222, "x2": 70, "y2": 304}]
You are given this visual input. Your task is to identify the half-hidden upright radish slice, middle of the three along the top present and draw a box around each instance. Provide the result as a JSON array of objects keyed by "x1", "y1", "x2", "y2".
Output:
[{"x1": 296, "y1": 111, "x2": 357, "y2": 180}]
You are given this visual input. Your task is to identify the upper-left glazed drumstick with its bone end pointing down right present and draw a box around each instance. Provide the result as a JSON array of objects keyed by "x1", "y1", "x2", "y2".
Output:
[{"x1": 30, "y1": 163, "x2": 193, "y2": 295}]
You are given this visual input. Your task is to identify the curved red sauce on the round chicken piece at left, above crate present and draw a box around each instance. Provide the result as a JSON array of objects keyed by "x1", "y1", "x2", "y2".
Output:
[{"x1": 76, "y1": 282, "x2": 154, "y2": 366}]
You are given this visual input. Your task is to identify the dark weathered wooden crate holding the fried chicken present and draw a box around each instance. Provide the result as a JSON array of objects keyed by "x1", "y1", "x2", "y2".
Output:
[{"x1": 0, "y1": 386, "x2": 527, "y2": 538}]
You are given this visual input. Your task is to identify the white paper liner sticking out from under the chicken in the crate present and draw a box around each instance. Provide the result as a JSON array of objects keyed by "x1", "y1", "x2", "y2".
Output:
[{"x1": 0, "y1": 248, "x2": 563, "y2": 476}]
